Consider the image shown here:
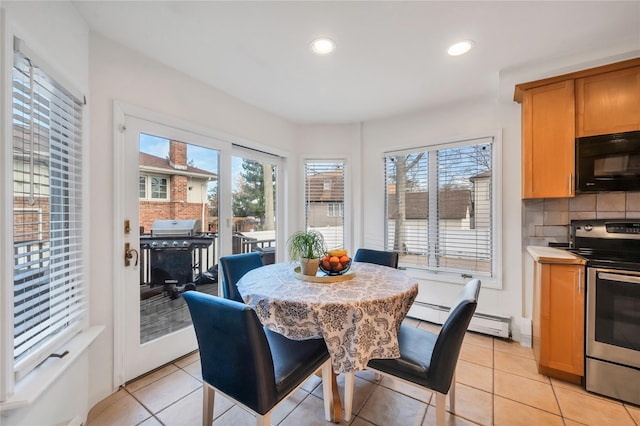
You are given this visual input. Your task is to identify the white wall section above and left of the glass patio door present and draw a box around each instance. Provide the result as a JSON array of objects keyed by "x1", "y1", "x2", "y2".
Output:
[{"x1": 89, "y1": 34, "x2": 297, "y2": 403}]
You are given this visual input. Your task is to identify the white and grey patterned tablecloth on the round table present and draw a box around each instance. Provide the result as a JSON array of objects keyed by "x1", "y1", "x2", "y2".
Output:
[{"x1": 237, "y1": 262, "x2": 418, "y2": 373}]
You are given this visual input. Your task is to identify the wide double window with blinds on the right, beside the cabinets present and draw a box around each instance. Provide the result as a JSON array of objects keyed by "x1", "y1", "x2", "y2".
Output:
[{"x1": 385, "y1": 138, "x2": 494, "y2": 276}]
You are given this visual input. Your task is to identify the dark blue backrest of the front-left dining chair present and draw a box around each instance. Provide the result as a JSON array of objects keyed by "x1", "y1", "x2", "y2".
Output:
[{"x1": 183, "y1": 291, "x2": 278, "y2": 413}]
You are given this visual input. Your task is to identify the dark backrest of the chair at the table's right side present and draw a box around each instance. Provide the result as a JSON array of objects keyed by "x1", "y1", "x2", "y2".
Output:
[{"x1": 428, "y1": 280, "x2": 480, "y2": 394}]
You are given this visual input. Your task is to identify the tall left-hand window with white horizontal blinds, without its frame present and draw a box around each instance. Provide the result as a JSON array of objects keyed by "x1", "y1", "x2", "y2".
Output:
[{"x1": 12, "y1": 47, "x2": 86, "y2": 378}]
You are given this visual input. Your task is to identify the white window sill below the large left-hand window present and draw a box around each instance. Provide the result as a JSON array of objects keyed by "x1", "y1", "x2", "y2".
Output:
[{"x1": 0, "y1": 325, "x2": 104, "y2": 412}]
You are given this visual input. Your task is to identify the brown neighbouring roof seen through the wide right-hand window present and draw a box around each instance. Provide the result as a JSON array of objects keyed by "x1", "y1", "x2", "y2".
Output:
[{"x1": 388, "y1": 189, "x2": 471, "y2": 219}]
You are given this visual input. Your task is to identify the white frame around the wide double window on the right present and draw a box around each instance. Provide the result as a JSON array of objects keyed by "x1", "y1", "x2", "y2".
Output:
[{"x1": 383, "y1": 134, "x2": 503, "y2": 289}]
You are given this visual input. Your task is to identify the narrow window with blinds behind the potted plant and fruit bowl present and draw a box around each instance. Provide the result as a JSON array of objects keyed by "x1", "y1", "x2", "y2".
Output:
[{"x1": 304, "y1": 160, "x2": 345, "y2": 250}]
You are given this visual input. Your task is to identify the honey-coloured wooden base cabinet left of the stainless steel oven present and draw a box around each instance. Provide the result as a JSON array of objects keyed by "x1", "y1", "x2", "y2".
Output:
[{"x1": 528, "y1": 247, "x2": 585, "y2": 383}]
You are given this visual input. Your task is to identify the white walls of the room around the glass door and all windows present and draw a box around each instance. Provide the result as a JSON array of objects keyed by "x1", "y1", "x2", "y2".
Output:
[{"x1": 2, "y1": 1, "x2": 636, "y2": 424}]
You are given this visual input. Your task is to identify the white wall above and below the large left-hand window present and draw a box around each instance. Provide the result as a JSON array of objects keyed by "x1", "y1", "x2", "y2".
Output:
[{"x1": 0, "y1": 1, "x2": 94, "y2": 425}]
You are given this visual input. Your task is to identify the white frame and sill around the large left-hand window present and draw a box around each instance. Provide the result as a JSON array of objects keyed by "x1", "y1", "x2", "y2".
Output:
[{"x1": 0, "y1": 35, "x2": 96, "y2": 404}]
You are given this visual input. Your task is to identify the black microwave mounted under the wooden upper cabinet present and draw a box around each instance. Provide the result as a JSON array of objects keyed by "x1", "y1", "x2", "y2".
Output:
[{"x1": 576, "y1": 130, "x2": 640, "y2": 192}]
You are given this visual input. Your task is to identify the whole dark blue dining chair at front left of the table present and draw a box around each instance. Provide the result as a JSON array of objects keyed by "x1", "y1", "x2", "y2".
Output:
[{"x1": 183, "y1": 291, "x2": 333, "y2": 426}]
